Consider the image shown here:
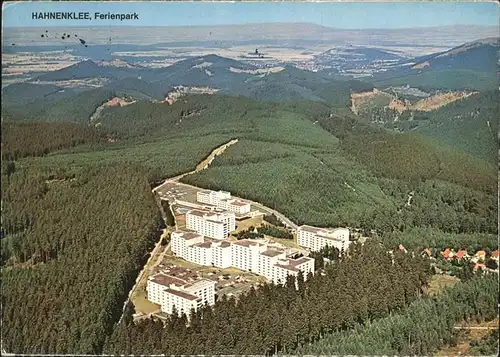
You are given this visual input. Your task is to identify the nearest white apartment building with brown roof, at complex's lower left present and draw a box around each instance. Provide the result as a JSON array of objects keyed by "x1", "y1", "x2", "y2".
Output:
[{"x1": 146, "y1": 273, "x2": 215, "y2": 315}]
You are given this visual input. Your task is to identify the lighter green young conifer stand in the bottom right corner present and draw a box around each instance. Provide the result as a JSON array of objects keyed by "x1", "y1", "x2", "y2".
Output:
[{"x1": 294, "y1": 275, "x2": 498, "y2": 356}]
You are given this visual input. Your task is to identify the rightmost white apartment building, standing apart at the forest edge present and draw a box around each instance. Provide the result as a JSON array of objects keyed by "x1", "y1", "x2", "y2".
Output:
[{"x1": 297, "y1": 225, "x2": 349, "y2": 251}]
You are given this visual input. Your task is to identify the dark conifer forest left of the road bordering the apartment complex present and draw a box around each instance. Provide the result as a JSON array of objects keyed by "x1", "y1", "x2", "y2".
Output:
[{"x1": 1, "y1": 165, "x2": 161, "y2": 354}]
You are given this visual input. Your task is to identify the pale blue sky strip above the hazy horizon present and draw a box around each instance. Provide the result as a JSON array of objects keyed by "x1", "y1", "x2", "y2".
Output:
[{"x1": 2, "y1": 1, "x2": 500, "y2": 29}]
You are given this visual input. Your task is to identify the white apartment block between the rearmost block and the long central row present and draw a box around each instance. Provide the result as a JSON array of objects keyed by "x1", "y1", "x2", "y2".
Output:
[{"x1": 186, "y1": 210, "x2": 236, "y2": 239}]
